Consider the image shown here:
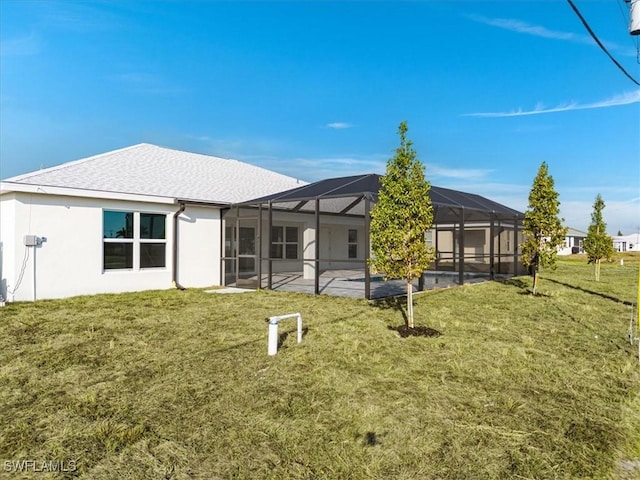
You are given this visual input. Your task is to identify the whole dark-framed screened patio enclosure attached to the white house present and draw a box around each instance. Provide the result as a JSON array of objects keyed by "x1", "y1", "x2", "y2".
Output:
[{"x1": 221, "y1": 174, "x2": 525, "y2": 299}]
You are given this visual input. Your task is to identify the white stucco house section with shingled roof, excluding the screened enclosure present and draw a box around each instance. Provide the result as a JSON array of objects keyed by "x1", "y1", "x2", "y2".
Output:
[{"x1": 0, "y1": 144, "x2": 306, "y2": 301}]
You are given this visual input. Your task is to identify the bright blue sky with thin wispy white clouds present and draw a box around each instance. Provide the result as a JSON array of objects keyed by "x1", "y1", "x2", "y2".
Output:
[{"x1": 0, "y1": 0, "x2": 640, "y2": 234}]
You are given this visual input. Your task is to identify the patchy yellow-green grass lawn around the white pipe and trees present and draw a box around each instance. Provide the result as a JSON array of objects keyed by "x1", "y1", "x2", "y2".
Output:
[{"x1": 0, "y1": 255, "x2": 640, "y2": 480}]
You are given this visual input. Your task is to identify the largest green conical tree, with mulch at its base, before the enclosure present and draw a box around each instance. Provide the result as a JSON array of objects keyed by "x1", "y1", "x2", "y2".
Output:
[{"x1": 370, "y1": 122, "x2": 435, "y2": 328}]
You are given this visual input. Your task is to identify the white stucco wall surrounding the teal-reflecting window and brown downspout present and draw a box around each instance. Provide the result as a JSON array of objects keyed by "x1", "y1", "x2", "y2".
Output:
[{"x1": 0, "y1": 192, "x2": 220, "y2": 301}]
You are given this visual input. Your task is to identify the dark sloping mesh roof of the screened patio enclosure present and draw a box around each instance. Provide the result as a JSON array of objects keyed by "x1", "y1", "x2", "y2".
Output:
[{"x1": 243, "y1": 173, "x2": 524, "y2": 221}]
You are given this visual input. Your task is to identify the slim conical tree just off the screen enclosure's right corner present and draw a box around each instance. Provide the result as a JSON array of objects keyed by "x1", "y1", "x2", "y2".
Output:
[{"x1": 520, "y1": 162, "x2": 567, "y2": 295}]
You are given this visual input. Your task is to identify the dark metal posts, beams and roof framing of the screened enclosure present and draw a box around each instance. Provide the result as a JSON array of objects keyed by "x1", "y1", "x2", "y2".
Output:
[{"x1": 226, "y1": 174, "x2": 524, "y2": 299}]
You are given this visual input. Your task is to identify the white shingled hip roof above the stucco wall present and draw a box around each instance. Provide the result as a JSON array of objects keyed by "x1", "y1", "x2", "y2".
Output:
[{"x1": 2, "y1": 143, "x2": 306, "y2": 204}]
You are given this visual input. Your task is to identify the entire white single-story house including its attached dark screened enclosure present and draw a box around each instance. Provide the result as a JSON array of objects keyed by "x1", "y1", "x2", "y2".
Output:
[{"x1": 0, "y1": 144, "x2": 523, "y2": 301}]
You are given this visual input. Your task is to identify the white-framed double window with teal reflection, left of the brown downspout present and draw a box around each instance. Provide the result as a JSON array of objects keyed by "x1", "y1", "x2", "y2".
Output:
[{"x1": 102, "y1": 210, "x2": 167, "y2": 270}]
